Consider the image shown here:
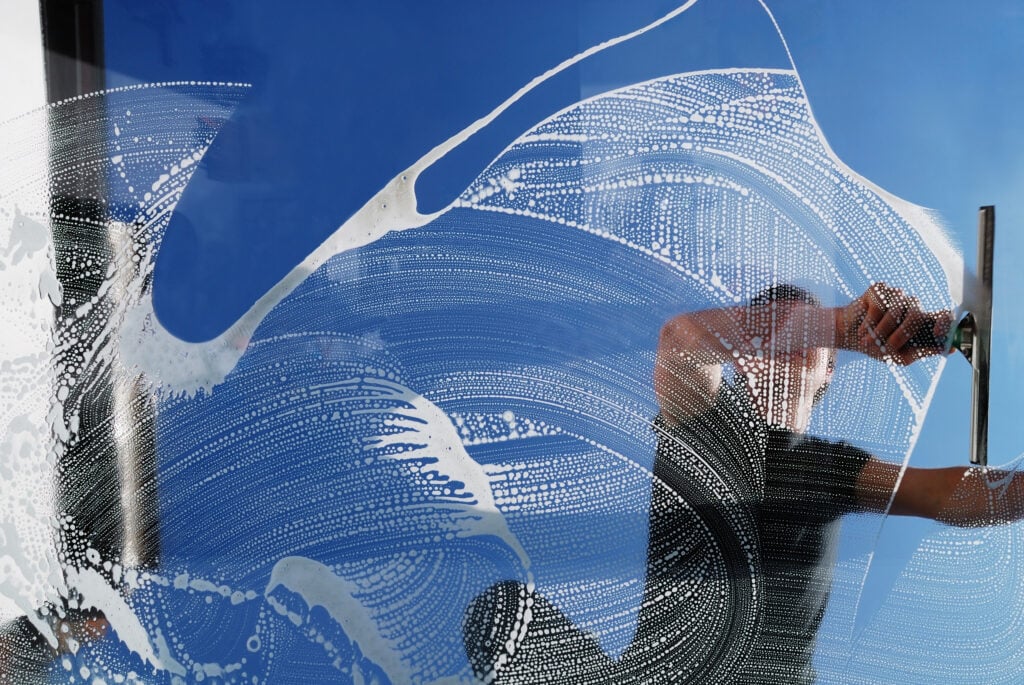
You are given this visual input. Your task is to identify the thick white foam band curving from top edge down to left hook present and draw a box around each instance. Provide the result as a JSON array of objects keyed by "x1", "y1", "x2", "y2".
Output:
[{"x1": 120, "y1": 0, "x2": 697, "y2": 394}]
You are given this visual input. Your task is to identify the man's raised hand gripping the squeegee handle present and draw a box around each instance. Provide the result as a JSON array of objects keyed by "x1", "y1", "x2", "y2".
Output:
[{"x1": 837, "y1": 283, "x2": 952, "y2": 366}]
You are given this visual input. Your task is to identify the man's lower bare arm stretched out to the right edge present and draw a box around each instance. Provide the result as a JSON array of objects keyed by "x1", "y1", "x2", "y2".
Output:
[{"x1": 857, "y1": 458, "x2": 1024, "y2": 526}]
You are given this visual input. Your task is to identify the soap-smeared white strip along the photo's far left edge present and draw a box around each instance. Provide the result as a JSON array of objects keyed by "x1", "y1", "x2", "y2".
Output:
[{"x1": 0, "y1": 96, "x2": 63, "y2": 644}]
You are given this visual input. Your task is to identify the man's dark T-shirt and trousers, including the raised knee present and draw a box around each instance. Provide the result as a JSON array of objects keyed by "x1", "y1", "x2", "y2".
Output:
[{"x1": 465, "y1": 386, "x2": 869, "y2": 685}]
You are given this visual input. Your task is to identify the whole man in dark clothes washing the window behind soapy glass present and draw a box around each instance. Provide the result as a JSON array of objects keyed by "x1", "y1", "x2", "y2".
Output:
[{"x1": 464, "y1": 284, "x2": 1024, "y2": 685}]
